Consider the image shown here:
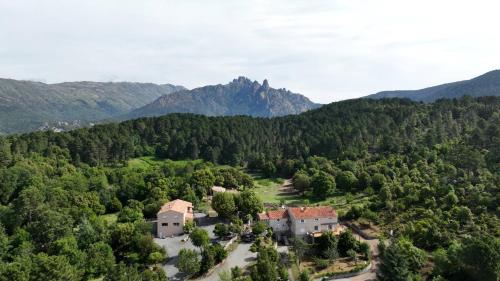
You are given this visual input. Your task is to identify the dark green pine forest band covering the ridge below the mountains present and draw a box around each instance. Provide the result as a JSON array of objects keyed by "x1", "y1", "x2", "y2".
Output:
[{"x1": 2, "y1": 97, "x2": 500, "y2": 168}]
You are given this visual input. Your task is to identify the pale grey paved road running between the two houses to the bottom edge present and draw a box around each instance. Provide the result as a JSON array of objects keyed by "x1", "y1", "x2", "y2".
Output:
[{"x1": 196, "y1": 242, "x2": 257, "y2": 281}]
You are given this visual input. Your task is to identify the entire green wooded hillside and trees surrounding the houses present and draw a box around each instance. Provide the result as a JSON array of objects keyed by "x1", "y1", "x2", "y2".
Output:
[{"x1": 0, "y1": 97, "x2": 500, "y2": 281}]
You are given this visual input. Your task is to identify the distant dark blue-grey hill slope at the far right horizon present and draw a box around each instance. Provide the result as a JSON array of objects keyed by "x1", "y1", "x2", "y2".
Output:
[{"x1": 367, "y1": 70, "x2": 500, "y2": 102}]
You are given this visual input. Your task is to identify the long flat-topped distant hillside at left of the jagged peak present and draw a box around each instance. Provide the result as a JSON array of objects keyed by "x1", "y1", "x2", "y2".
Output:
[{"x1": 0, "y1": 79, "x2": 185, "y2": 134}]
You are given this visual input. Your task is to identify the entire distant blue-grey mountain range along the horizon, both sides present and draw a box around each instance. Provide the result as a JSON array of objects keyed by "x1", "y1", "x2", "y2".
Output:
[{"x1": 0, "y1": 70, "x2": 500, "y2": 135}]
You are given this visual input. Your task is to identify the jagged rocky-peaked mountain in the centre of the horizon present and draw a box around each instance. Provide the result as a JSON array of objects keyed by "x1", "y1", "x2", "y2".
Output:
[{"x1": 123, "y1": 77, "x2": 320, "y2": 119}]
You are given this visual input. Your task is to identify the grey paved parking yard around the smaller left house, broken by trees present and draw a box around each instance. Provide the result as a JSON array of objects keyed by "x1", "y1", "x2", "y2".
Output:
[{"x1": 154, "y1": 213, "x2": 216, "y2": 281}]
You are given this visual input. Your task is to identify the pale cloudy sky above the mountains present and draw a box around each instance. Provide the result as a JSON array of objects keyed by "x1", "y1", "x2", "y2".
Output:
[{"x1": 0, "y1": 0, "x2": 500, "y2": 103}]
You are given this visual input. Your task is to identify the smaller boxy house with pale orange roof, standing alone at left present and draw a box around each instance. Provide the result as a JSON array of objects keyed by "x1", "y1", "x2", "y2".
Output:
[{"x1": 156, "y1": 199, "x2": 194, "y2": 238}]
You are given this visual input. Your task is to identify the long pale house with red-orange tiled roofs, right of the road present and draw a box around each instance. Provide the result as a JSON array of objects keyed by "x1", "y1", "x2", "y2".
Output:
[{"x1": 259, "y1": 206, "x2": 338, "y2": 237}]
